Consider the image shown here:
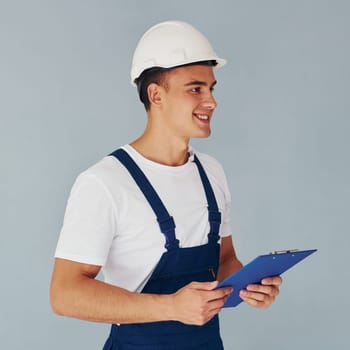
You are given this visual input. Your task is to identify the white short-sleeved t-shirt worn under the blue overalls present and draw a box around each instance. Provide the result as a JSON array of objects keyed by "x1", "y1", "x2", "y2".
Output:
[{"x1": 55, "y1": 145, "x2": 231, "y2": 292}]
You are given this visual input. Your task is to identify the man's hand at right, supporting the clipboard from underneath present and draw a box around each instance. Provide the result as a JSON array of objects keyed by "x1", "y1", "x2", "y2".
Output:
[{"x1": 239, "y1": 276, "x2": 282, "y2": 308}]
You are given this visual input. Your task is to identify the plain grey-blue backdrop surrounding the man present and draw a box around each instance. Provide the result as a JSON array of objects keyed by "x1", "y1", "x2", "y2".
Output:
[{"x1": 0, "y1": 0, "x2": 350, "y2": 350}]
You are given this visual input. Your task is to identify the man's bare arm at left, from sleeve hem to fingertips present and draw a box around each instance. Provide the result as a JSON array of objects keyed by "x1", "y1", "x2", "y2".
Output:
[{"x1": 50, "y1": 258, "x2": 231, "y2": 325}]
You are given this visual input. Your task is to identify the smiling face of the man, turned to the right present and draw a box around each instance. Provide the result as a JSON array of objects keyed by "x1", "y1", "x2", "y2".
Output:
[{"x1": 162, "y1": 65, "x2": 217, "y2": 140}]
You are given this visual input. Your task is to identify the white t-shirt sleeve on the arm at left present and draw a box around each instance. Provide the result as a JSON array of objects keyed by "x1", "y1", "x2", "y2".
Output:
[{"x1": 55, "y1": 173, "x2": 116, "y2": 266}]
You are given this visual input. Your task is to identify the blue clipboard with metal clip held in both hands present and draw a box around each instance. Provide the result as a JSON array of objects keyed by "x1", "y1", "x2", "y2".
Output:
[{"x1": 217, "y1": 249, "x2": 317, "y2": 307}]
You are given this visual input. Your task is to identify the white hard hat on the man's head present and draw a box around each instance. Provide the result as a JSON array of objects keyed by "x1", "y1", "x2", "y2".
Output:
[{"x1": 131, "y1": 21, "x2": 226, "y2": 85}]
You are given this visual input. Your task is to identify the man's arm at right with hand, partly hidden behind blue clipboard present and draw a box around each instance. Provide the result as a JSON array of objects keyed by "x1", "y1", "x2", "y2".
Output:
[{"x1": 217, "y1": 236, "x2": 282, "y2": 308}]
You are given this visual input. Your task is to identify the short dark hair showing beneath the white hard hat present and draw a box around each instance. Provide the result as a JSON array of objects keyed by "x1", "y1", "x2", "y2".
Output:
[{"x1": 135, "y1": 60, "x2": 218, "y2": 111}]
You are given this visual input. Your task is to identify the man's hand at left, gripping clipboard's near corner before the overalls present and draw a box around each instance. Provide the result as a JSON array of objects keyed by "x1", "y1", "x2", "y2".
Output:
[{"x1": 172, "y1": 281, "x2": 232, "y2": 326}]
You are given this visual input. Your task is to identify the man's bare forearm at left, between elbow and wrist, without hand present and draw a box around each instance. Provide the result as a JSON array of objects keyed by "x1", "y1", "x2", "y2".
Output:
[{"x1": 51, "y1": 276, "x2": 174, "y2": 324}]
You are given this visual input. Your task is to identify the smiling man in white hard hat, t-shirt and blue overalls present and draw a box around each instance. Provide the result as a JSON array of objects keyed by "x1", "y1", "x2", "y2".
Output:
[{"x1": 51, "y1": 21, "x2": 281, "y2": 350}]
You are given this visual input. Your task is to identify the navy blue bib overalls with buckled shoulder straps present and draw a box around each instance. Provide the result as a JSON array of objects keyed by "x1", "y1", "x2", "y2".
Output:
[{"x1": 103, "y1": 149, "x2": 223, "y2": 350}]
